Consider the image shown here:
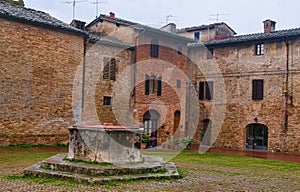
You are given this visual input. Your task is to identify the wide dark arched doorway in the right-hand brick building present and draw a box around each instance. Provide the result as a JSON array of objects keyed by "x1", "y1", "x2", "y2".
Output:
[{"x1": 246, "y1": 123, "x2": 268, "y2": 150}]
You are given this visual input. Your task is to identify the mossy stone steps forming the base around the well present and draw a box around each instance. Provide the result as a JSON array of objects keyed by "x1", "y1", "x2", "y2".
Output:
[{"x1": 24, "y1": 154, "x2": 179, "y2": 184}]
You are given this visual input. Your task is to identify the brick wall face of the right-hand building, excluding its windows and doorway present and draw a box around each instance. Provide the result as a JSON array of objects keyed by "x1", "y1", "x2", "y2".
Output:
[{"x1": 190, "y1": 40, "x2": 300, "y2": 153}]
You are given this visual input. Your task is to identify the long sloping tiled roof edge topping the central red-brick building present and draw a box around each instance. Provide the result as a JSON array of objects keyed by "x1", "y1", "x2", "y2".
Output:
[{"x1": 86, "y1": 14, "x2": 195, "y2": 42}]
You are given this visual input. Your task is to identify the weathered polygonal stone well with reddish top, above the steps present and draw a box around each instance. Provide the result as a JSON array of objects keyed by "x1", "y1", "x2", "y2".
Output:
[{"x1": 67, "y1": 125, "x2": 143, "y2": 164}]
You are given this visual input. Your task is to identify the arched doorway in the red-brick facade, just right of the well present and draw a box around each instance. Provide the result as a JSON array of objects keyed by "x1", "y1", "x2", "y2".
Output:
[{"x1": 143, "y1": 110, "x2": 160, "y2": 147}]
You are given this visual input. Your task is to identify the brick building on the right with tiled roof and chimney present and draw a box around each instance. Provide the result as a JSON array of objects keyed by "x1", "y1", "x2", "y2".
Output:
[{"x1": 189, "y1": 20, "x2": 300, "y2": 153}]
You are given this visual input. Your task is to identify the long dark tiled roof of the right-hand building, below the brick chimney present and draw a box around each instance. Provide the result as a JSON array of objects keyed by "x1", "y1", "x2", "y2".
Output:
[{"x1": 190, "y1": 28, "x2": 300, "y2": 47}]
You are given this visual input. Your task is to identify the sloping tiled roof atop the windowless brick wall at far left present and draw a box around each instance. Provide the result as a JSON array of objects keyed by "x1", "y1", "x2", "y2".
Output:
[{"x1": 0, "y1": 1, "x2": 85, "y2": 35}]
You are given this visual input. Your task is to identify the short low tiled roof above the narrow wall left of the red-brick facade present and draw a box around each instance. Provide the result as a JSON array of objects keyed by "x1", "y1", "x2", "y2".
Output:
[{"x1": 89, "y1": 34, "x2": 134, "y2": 49}]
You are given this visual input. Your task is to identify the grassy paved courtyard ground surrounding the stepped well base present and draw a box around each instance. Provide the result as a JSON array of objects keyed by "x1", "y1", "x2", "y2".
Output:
[{"x1": 0, "y1": 147, "x2": 300, "y2": 192}]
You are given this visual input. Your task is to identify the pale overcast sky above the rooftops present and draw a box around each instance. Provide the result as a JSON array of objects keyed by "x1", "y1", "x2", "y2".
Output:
[{"x1": 24, "y1": 0, "x2": 300, "y2": 34}]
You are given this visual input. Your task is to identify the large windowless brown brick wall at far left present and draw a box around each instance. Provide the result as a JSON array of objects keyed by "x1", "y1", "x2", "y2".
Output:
[{"x1": 0, "y1": 19, "x2": 84, "y2": 145}]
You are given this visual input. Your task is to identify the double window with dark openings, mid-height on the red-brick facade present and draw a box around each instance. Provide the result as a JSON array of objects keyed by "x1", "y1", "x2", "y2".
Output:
[{"x1": 145, "y1": 75, "x2": 162, "y2": 96}]
